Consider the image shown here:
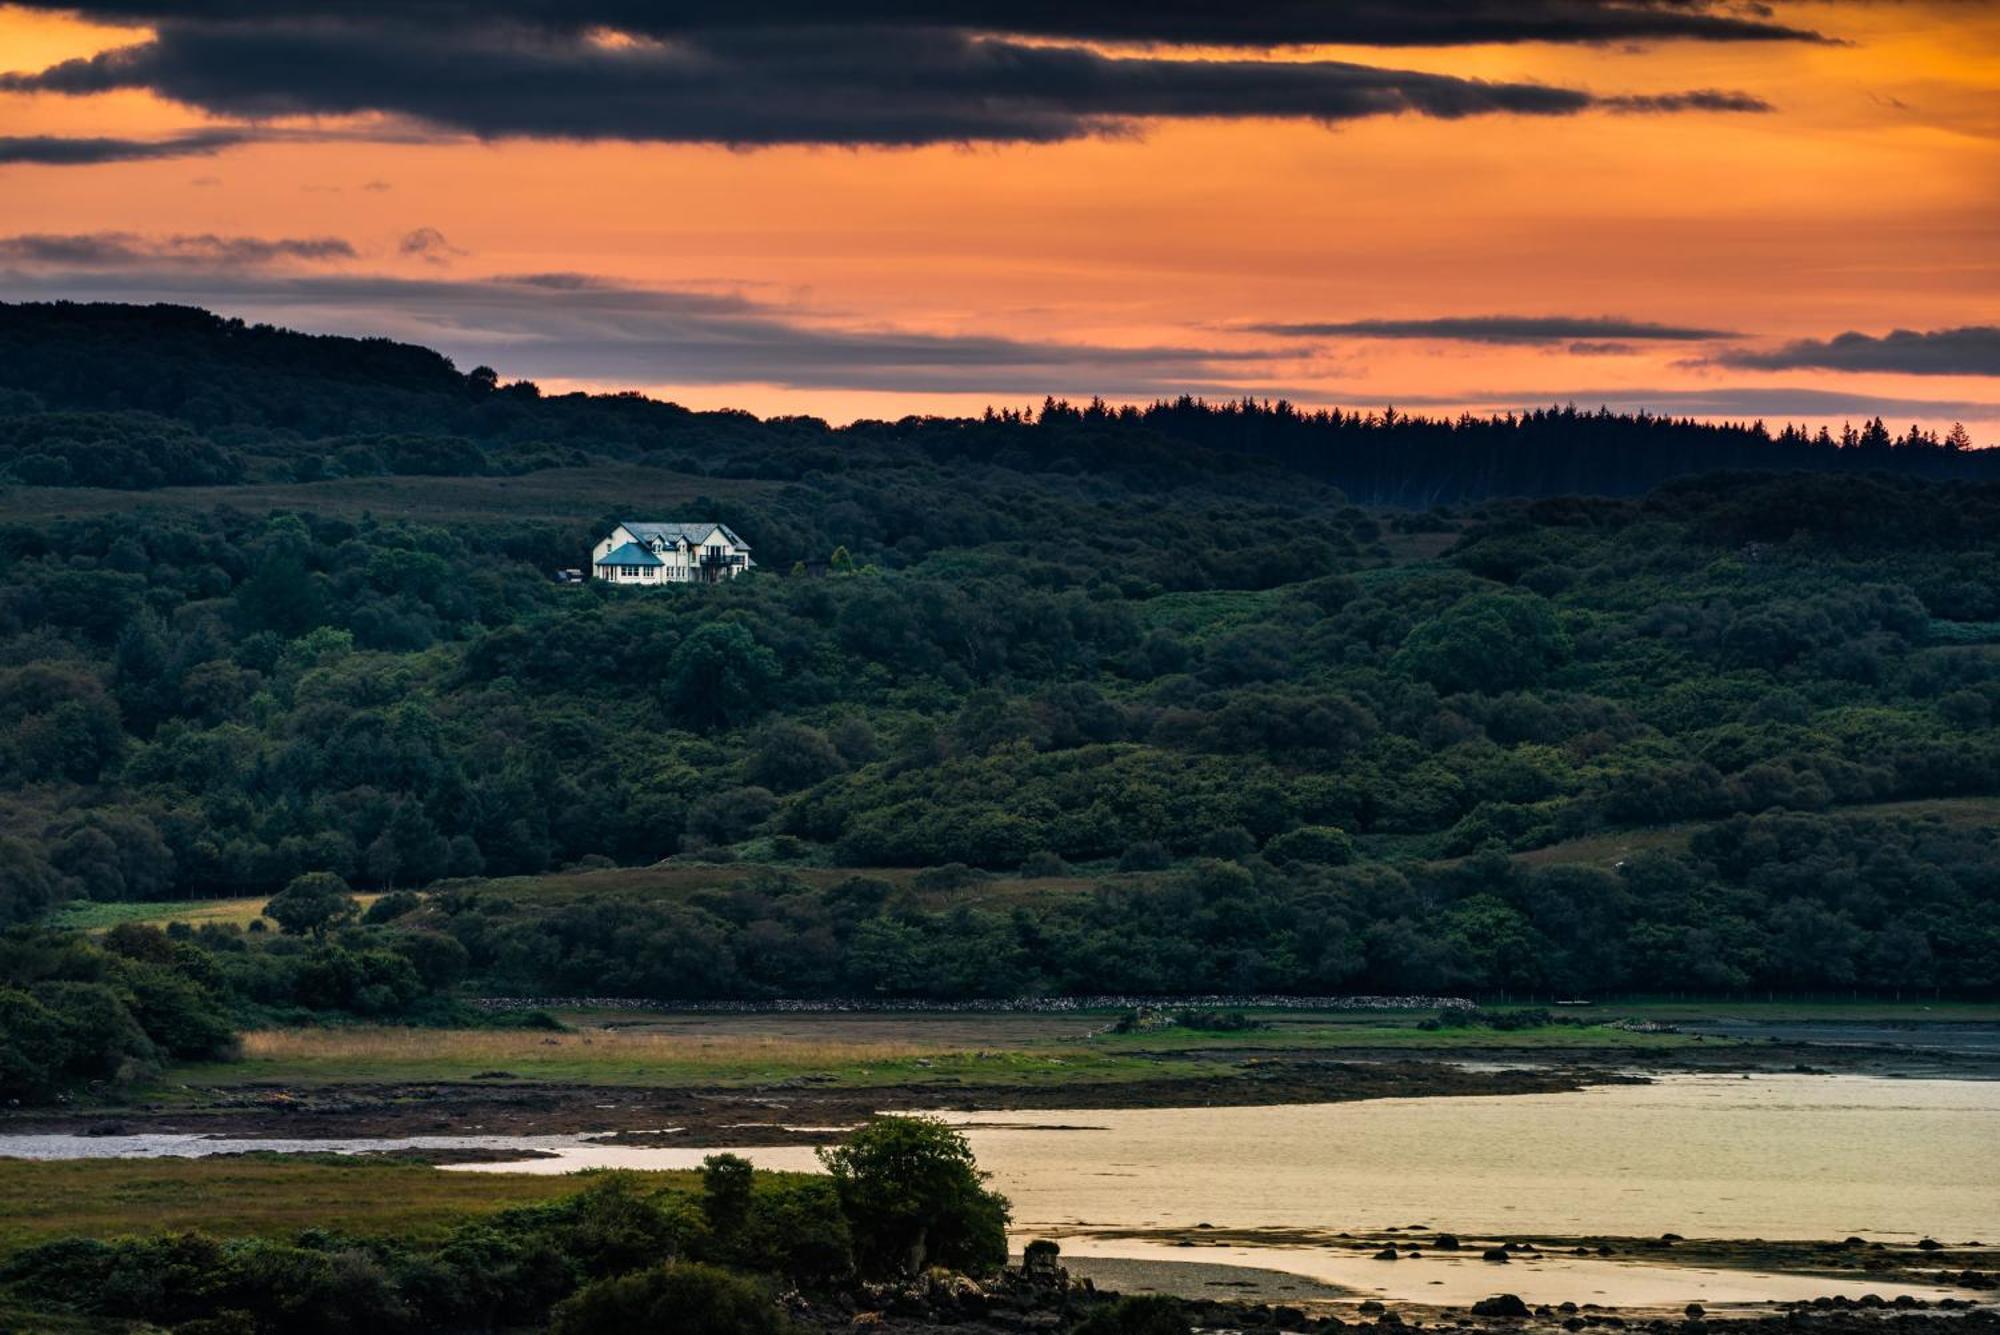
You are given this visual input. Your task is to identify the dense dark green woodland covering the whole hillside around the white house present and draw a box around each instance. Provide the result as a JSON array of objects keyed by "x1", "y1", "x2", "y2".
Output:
[{"x1": 0, "y1": 299, "x2": 2000, "y2": 1055}]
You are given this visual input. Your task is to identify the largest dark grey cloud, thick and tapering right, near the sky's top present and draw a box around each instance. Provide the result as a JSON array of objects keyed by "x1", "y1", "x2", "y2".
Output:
[{"x1": 0, "y1": 4, "x2": 1768, "y2": 146}]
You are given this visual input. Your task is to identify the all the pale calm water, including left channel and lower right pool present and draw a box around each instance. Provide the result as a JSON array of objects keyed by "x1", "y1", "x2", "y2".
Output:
[{"x1": 0, "y1": 1075, "x2": 2000, "y2": 1303}]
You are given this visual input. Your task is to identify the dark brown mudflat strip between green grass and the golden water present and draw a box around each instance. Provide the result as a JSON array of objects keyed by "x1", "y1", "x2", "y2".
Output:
[{"x1": 11, "y1": 1037, "x2": 2000, "y2": 1145}]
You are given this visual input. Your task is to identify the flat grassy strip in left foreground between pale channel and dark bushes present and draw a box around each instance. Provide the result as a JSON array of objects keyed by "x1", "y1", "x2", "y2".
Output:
[{"x1": 0, "y1": 1155, "x2": 632, "y2": 1253}]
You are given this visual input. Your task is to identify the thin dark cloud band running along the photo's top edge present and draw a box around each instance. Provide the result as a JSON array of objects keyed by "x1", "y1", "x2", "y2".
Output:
[{"x1": 0, "y1": 0, "x2": 1824, "y2": 46}]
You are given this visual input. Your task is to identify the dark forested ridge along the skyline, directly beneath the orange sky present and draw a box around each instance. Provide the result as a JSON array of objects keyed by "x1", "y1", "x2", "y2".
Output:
[{"x1": 0, "y1": 304, "x2": 2000, "y2": 506}]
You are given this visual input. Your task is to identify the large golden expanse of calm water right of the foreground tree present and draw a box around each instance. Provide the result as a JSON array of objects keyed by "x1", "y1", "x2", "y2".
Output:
[{"x1": 936, "y1": 1075, "x2": 2000, "y2": 1243}]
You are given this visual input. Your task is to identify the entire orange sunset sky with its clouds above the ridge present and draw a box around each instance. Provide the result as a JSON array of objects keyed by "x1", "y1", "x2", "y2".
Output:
[{"x1": 0, "y1": 0, "x2": 2000, "y2": 433}]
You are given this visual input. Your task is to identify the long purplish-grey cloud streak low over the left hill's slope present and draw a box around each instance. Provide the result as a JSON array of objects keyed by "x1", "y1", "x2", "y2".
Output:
[{"x1": 0, "y1": 262, "x2": 1296, "y2": 398}]
